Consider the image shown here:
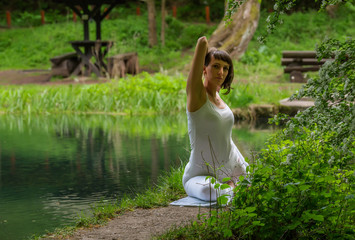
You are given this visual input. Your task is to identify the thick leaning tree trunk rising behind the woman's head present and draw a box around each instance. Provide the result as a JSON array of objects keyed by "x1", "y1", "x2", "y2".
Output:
[{"x1": 208, "y1": 0, "x2": 260, "y2": 59}]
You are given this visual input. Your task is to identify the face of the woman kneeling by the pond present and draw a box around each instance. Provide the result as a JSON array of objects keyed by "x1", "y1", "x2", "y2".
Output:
[{"x1": 204, "y1": 56, "x2": 229, "y2": 87}]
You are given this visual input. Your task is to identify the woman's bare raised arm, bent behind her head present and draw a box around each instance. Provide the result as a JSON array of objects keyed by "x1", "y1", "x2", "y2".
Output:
[{"x1": 186, "y1": 37, "x2": 208, "y2": 112}]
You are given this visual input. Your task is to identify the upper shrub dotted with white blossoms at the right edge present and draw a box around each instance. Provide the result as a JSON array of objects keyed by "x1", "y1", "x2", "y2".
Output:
[{"x1": 288, "y1": 39, "x2": 355, "y2": 157}]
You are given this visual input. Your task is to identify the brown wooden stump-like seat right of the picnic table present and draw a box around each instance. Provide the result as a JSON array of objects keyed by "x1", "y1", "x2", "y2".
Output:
[{"x1": 107, "y1": 53, "x2": 139, "y2": 78}]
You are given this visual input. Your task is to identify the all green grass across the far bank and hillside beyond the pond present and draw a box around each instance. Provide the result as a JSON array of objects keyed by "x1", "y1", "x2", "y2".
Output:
[{"x1": 0, "y1": 6, "x2": 355, "y2": 114}]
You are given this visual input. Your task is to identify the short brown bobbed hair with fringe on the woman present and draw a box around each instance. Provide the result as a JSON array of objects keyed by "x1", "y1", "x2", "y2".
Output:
[{"x1": 205, "y1": 48, "x2": 234, "y2": 95}]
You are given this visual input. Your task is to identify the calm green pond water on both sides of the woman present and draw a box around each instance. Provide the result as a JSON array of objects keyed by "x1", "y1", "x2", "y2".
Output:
[{"x1": 0, "y1": 114, "x2": 274, "y2": 240}]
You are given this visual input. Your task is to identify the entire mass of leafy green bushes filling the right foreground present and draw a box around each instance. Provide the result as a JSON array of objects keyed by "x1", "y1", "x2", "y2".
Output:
[{"x1": 229, "y1": 39, "x2": 355, "y2": 239}]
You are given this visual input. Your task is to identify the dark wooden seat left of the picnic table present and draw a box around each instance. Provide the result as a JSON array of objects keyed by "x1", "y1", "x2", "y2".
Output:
[{"x1": 50, "y1": 52, "x2": 80, "y2": 77}]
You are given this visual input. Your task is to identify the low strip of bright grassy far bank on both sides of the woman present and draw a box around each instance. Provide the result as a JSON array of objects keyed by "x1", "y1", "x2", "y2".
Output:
[{"x1": 0, "y1": 73, "x2": 300, "y2": 115}]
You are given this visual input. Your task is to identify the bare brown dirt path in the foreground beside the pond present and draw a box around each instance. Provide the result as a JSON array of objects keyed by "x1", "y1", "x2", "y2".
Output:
[{"x1": 47, "y1": 206, "x2": 209, "y2": 240}]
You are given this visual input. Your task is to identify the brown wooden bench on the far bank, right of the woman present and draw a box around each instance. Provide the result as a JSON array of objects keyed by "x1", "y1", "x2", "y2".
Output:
[{"x1": 281, "y1": 51, "x2": 330, "y2": 83}]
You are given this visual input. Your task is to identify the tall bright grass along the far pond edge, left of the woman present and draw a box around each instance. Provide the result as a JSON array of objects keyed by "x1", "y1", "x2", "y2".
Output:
[{"x1": 0, "y1": 73, "x2": 186, "y2": 114}]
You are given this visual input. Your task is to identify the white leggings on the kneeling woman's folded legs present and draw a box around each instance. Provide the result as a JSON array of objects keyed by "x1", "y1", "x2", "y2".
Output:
[{"x1": 184, "y1": 176, "x2": 233, "y2": 201}]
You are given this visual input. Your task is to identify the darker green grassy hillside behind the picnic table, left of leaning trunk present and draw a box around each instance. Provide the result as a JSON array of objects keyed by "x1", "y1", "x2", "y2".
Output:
[{"x1": 0, "y1": 12, "x2": 215, "y2": 71}]
